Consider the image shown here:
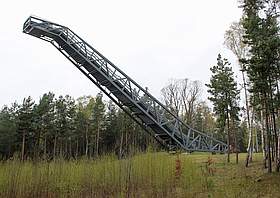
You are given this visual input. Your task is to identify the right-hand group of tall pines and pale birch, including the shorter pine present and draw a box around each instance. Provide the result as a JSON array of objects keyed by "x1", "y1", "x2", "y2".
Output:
[{"x1": 219, "y1": 0, "x2": 280, "y2": 172}]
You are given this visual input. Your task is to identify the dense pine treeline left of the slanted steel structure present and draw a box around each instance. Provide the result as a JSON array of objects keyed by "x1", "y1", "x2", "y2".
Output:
[{"x1": 0, "y1": 93, "x2": 158, "y2": 160}]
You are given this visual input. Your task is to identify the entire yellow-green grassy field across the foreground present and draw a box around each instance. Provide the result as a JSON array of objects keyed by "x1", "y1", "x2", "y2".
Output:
[{"x1": 0, "y1": 153, "x2": 280, "y2": 198}]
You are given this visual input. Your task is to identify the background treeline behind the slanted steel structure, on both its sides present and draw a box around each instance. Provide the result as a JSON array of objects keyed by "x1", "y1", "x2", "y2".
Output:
[{"x1": 0, "y1": 76, "x2": 246, "y2": 160}]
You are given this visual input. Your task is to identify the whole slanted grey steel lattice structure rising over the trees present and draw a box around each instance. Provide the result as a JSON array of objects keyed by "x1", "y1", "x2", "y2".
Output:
[{"x1": 23, "y1": 16, "x2": 228, "y2": 153}]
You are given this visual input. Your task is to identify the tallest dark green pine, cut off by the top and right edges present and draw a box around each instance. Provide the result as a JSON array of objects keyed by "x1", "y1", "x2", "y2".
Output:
[{"x1": 242, "y1": 0, "x2": 280, "y2": 172}]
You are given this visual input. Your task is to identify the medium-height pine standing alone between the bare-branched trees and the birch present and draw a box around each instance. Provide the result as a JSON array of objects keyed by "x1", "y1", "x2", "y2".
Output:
[{"x1": 206, "y1": 54, "x2": 239, "y2": 162}]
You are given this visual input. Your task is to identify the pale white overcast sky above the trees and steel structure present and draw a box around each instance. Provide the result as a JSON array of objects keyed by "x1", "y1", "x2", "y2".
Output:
[{"x1": 0, "y1": 0, "x2": 241, "y2": 107}]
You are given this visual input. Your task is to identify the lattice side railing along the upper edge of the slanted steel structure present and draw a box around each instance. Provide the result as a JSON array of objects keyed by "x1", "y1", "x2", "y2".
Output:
[{"x1": 23, "y1": 16, "x2": 227, "y2": 152}]
